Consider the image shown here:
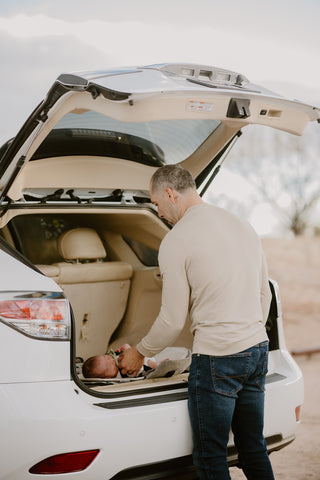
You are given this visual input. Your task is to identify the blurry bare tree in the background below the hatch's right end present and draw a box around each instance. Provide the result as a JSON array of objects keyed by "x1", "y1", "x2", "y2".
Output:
[{"x1": 212, "y1": 125, "x2": 320, "y2": 235}]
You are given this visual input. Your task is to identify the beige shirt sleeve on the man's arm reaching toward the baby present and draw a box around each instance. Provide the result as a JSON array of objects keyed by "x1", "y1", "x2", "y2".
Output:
[{"x1": 137, "y1": 232, "x2": 190, "y2": 356}]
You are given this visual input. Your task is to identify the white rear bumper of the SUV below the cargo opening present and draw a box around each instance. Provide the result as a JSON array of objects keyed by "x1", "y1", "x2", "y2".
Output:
[{"x1": 0, "y1": 352, "x2": 303, "y2": 480}]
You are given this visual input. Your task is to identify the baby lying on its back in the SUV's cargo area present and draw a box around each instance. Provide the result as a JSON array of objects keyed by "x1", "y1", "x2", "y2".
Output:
[{"x1": 82, "y1": 343, "x2": 161, "y2": 378}]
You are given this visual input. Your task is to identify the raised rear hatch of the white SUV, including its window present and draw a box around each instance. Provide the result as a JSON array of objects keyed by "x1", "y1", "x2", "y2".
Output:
[{"x1": 0, "y1": 64, "x2": 319, "y2": 206}]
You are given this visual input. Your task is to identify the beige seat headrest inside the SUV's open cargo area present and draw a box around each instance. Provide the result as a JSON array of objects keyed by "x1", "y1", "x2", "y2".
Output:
[{"x1": 58, "y1": 228, "x2": 107, "y2": 261}]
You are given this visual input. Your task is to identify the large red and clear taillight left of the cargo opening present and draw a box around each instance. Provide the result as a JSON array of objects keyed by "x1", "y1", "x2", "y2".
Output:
[{"x1": 0, "y1": 292, "x2": 70, "y2": 340}]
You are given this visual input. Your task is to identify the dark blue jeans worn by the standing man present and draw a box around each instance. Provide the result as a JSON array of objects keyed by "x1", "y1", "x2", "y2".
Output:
[{"x1": 188, "y1": 341, "x2": 274, "y2": 480}]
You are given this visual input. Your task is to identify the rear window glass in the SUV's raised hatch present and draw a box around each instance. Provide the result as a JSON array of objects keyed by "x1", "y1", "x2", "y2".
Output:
[{"x1": 32, "y1": 111, "x2": 220, "y2": 166}]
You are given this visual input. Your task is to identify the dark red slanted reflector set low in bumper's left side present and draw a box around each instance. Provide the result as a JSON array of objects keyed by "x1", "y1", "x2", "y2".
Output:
[{"x1": 29, "y1": 450, "x2": 100, "y2": 475}]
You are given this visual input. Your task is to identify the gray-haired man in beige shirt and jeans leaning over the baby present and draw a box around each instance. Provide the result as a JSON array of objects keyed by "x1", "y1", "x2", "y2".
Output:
[{"x1": 119, "y1": 165, "x2": 274, "y2": 480}]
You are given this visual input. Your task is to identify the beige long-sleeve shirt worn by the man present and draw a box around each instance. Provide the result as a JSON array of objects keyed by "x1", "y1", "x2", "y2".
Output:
[{"x1": 137, "y1": 203, "x2": 271, "y2": 356}]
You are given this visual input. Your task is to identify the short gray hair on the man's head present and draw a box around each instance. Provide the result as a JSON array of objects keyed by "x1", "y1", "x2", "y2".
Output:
[{"x1": 151, "y1": 165, "x2": 196, "y2": 192}]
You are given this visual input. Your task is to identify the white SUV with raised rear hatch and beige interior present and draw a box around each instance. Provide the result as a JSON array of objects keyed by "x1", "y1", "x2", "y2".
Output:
[{"x1": 0, "y1": 64, "x2": 320, "y2": 480}]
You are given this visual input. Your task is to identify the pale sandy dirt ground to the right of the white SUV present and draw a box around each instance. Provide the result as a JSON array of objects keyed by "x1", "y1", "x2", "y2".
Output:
[{"x1": 231, "y1": 237, "x2": 320, "y2": 480}]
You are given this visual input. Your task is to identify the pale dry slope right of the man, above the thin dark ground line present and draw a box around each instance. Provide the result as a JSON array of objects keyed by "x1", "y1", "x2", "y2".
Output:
[{"x1": 263, "y1": 237, "x2": 320, "y2": 352}]
